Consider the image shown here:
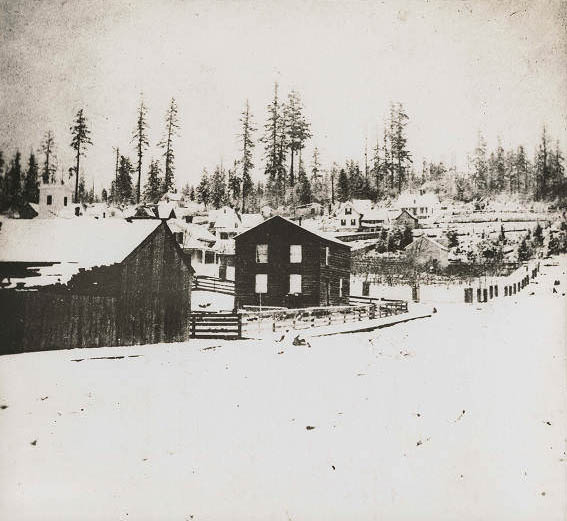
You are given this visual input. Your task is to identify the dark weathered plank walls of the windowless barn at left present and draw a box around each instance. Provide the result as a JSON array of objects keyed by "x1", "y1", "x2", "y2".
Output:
[{"x1": 0, "y1": 219, "x2": 191, "y2": 354}]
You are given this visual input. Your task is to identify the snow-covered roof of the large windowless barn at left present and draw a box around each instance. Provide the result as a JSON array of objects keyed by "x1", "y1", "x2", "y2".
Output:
[{"x1": 0, "y1": 217, "x2": 160, "y2": 268}]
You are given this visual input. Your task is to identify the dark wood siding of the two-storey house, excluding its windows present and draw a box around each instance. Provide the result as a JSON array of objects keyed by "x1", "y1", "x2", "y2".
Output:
[{"x1": 235, "y1": 218, "x2": 350, "y2": 308}]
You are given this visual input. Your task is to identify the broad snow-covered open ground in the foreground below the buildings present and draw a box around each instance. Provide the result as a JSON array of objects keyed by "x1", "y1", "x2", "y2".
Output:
[{"x1": 0, "y1": 258, "x2": 567, "y2": 521}]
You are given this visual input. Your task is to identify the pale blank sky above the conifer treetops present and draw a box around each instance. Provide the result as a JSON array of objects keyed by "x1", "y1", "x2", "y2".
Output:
[{"x1": 0, "y1": 0, "x2": 567, "y2": 192}]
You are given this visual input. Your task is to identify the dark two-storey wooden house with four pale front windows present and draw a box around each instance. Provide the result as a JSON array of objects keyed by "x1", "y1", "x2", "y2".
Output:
[{"x1": 235, "y1": 216, "x2": 351, "y2": 308}]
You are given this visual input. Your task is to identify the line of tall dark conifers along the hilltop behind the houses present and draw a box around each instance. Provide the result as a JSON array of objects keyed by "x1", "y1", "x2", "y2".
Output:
[{"x1": 0, "y1": 83, "x2": 567, "y2": 212}]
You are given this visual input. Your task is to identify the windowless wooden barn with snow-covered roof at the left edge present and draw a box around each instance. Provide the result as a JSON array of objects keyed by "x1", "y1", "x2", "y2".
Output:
[{"x1": 0, "y1": 218, "x2": 192, "y2": 353}]
